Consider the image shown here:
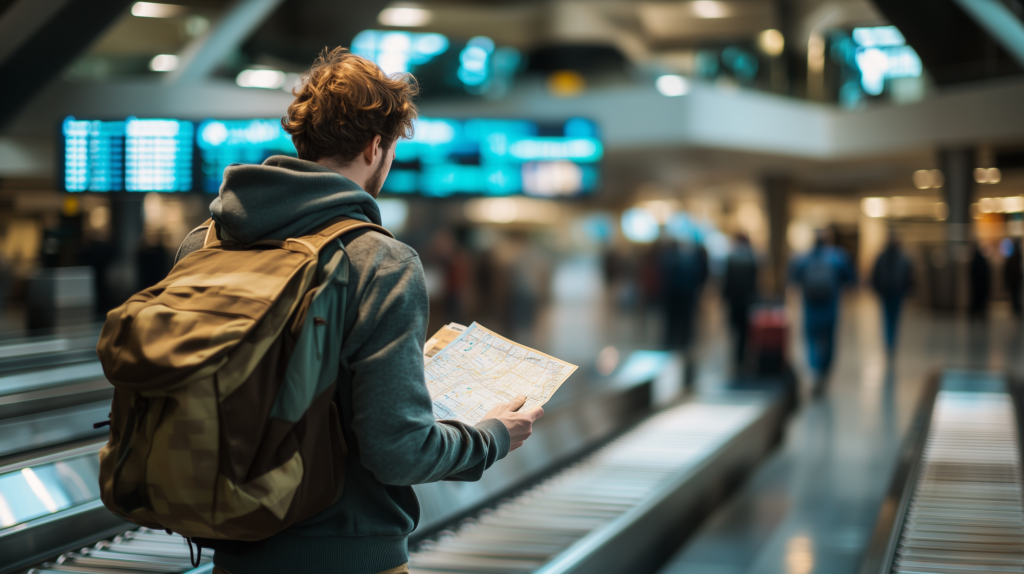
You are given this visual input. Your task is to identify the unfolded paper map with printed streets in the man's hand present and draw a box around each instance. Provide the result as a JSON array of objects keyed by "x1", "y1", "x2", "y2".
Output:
[{"x1": 426, "y1": 323, "x2": 577, "y2": 425}]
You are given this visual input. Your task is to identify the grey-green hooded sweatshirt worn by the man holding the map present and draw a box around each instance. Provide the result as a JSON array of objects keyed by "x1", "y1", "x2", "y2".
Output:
[{"x1": 175, "y1": 156, "x2": 511, "y2": 574}]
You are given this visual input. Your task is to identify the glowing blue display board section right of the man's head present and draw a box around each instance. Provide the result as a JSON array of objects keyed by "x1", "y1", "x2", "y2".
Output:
[{"x1": 384, "y1": 118, "x2": 604, "y2": 197}]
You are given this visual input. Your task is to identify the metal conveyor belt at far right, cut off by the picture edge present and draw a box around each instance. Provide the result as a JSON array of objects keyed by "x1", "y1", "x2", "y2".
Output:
[{"x1": 860, "y1": 370, "x2": 1024, "y2": 574}]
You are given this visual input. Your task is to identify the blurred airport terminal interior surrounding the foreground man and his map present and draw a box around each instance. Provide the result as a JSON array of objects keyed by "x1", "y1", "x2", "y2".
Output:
[{"x1": 0, "y1": 0, "x2": 1024, "y2": 574}]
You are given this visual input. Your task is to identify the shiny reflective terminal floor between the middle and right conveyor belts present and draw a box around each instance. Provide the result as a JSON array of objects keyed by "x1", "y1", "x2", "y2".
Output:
[{"x1": 659, "y1": 293, "x2": 1024, "y2": 574}]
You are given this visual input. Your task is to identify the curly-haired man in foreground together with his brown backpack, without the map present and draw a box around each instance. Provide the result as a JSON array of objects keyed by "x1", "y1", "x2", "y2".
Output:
[{"x1": 97, "y1": 48, "x2": 543, "y2": 574}]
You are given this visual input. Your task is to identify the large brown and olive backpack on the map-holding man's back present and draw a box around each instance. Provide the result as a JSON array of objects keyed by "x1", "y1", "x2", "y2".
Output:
[{"x1": 96, "y1": 219, "x2": 391, "y2": 541}]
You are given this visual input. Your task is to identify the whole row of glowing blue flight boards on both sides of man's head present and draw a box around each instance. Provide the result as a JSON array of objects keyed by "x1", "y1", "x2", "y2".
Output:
[{"x1": 60, "y1": 118, "x2": 604, "y2": 197}]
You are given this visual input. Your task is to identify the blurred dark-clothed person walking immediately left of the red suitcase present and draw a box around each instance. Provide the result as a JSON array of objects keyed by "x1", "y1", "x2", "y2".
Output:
[{"x1": 722, "y1": 233, "x2": 758, "y2": 367}]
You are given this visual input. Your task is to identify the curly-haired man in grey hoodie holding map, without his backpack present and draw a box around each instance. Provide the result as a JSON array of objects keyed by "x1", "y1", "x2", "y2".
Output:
[{"x1": 176, "y1": 48, "x2": 543, "y2": 574}]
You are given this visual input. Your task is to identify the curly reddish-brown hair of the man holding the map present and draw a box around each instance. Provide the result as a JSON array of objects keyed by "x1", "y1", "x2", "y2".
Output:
[{"x1": 281, "y1": 47, "x2": 419, "y2": 163}]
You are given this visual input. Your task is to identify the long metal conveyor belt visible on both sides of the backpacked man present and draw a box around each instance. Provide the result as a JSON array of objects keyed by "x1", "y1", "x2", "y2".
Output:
[{"x1": 0, "y1": 351, "x2": 782, "y2": 574}]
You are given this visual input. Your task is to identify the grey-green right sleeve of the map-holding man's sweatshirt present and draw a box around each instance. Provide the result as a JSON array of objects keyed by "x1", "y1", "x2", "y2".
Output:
[{"x1": 348, "y1": 257, "x2": 511, "y2": 486}]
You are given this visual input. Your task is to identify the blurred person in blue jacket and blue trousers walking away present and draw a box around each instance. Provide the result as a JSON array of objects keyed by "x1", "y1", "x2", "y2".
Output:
[{"x1": 790, "y1": 229, "x2": 857, "y2": 396}]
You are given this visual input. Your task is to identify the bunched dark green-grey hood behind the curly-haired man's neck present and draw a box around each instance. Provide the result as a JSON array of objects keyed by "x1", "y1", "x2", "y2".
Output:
[{"x1": 210, "y1": 156, "x2": 381, "y2": 244}]
